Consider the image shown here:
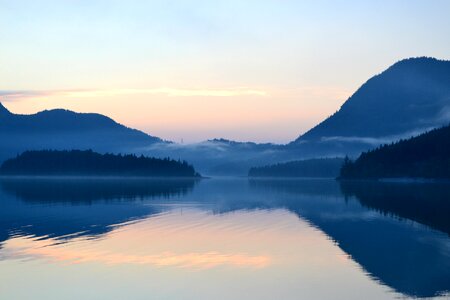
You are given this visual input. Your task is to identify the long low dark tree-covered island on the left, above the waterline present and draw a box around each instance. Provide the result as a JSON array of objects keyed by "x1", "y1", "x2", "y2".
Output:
[{"x1": 0, "y1": 150, "x2": 200, "y2": 178}]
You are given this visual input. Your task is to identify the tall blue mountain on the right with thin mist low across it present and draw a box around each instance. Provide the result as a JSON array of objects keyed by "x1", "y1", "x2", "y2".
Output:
[{"x1": 289, "y1": 57, "x2": 450, "y2": 155}]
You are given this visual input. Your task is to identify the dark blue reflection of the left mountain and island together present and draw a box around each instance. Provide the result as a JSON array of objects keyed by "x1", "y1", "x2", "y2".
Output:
[{"x1": 0, "y1": 178, "x2": 195, "y2": 242}]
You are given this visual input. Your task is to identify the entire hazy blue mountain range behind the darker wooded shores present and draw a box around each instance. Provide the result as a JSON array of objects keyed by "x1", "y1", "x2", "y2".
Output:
[{"x1": 0, "y1": 57, "x2": 450, "y2": 176}]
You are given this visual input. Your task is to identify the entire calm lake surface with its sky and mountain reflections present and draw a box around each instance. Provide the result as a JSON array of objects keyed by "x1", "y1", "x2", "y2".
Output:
[{"x1": 0, "y1": 178, "x2": 450, "y2": 300}]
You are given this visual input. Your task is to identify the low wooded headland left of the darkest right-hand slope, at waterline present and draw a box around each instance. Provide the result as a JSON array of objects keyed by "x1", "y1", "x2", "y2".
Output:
[{"x1": 248, "y1": 158, "x2": 344, "y2": 178}]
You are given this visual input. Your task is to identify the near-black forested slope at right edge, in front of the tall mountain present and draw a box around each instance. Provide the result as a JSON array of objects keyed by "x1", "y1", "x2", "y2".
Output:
[{"x1": 340, "y1": 126, "x2": 450, "y2": 179}]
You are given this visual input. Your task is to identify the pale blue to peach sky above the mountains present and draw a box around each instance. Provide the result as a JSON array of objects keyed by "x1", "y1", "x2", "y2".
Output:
[{"x1": 0, "y1": 0, "x2": 450, "y2": 143}]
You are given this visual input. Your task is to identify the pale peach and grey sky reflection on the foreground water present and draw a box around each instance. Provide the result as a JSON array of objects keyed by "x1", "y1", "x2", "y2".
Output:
[{"x1": 0, "y1": 206, "x2": 395, "y2": 299}]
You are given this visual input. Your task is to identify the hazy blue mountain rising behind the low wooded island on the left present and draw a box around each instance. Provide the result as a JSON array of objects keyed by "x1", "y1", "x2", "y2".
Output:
[{"x1": 0, "y1": 103, "x2": 163, "y2": 161}]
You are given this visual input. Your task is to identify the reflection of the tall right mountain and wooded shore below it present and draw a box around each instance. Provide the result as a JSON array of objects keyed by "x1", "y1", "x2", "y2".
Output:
[{"x1": 250, "y1": 180, "x2": 450, "y2": 297}]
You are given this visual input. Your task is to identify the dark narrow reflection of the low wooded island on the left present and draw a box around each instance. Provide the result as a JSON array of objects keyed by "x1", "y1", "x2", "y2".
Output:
[{"x1": 0, "y1": 177, "x2": 198, "y2": 203}]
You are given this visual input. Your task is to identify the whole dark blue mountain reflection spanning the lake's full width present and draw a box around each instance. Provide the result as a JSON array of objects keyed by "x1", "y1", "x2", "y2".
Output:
[{"x1": 0, "y1": 178, "x2": 450, "y2": 297}]
